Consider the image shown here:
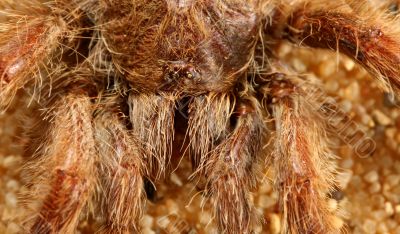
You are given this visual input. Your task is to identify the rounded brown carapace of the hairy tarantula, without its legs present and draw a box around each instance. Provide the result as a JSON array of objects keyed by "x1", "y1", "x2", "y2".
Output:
[{"x1": 103, "y1": 1, "x2": 261, "y2": 93}]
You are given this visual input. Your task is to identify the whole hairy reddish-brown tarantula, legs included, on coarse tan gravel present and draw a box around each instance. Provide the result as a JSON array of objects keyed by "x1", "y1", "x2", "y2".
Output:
[{"x1": 0, "y1": 0, "x2": 400, "y2": 233}]
